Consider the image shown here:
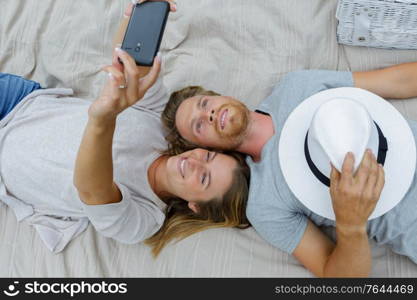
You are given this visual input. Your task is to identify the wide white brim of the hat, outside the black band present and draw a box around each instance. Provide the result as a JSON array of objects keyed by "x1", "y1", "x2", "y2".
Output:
[{"x1": 279, "y1": 87, "x2": 416, "y2": 220}]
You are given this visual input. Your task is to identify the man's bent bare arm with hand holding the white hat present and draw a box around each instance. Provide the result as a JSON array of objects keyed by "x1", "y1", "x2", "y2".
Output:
[{"x1": 293, "y1": 153, "x2": 384, "y2": 277}]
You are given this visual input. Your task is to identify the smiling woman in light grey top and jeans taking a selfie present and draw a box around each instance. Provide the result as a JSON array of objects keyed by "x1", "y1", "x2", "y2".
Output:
[{"x1": 0, "y1": 1, "x2": 248, "y2": 254}]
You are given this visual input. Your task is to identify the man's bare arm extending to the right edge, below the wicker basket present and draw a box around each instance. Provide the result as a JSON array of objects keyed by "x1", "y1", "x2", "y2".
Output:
[{"x1": 353, "y1": 62, "x2": 417, "y2": 99}]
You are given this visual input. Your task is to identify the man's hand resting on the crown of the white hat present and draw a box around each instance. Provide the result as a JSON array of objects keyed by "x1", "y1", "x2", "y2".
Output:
[{"x1": 330, "y1": 150, "x2": 385, "y2": 234}]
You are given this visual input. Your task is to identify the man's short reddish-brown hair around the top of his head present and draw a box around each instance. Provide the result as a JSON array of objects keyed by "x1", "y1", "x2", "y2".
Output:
[{"x1": 161, "y1": 86, "x2": 220, "y2": 155}]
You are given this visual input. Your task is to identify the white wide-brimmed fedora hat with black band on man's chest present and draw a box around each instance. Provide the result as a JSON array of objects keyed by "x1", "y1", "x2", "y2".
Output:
[{"x1": 279, "y1": 88, "x2": 416, "y2": 220}]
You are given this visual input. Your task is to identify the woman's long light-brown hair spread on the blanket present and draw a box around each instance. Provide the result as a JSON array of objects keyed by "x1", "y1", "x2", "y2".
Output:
[{"x1": 145, "y1": 153, "x2": 251, "y2": 257}]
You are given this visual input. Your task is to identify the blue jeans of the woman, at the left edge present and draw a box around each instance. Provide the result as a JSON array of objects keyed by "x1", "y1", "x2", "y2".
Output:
[{"x1": 0, "y1": 72, "x2": 41, "y2": 120}]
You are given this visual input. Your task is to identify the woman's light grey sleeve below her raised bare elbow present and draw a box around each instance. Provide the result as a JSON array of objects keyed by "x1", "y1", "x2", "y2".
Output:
[{"x1": 83, "y1": 184, "x2": 164, "y2": 244}]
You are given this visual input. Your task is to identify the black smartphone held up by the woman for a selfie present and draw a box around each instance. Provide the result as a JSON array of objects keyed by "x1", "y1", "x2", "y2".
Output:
[{"x1": 121, "y1": 1, "x2": 169, "y2": 66}]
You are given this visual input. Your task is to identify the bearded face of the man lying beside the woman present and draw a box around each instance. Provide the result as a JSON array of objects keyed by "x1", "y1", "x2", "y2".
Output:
[{"x1": 175, "y1": 95, "x2": 249, "y2": 150}]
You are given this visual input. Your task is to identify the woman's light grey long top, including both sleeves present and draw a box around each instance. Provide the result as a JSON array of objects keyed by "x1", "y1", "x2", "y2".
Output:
[{"x1": 0, "y1": 79, "x2": 168, "y2": 252}]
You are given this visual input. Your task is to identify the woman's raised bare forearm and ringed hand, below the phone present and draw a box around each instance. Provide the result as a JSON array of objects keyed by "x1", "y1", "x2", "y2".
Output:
[{"x1": 74, "y1": 49, "x2": 161, "y2": 205}]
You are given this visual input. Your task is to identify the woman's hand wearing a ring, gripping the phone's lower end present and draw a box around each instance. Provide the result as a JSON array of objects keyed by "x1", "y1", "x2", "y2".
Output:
[{"x1": 88, "y1": 48, "x2": 161, "y2": 121}]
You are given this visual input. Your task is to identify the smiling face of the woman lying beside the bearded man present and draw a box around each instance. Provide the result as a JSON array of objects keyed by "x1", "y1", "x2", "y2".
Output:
[{"x1": 167, "y1": 149, "x2": 237, "y2": 203}]
